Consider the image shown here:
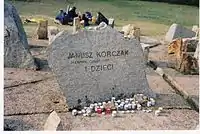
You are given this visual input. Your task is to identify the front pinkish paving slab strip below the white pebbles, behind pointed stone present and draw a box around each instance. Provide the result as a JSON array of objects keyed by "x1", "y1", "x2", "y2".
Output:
[{"x1": 4, "y1": 109, "x2": 199, "y2": 131}]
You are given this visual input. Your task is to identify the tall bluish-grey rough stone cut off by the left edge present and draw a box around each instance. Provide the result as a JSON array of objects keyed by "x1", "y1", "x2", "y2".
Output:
[{"x1": 4, "y1": 2, "x2": 37, "y2": 69}]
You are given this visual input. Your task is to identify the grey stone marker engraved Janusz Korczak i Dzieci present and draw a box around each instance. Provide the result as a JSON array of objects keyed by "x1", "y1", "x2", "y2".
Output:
[{"x1": 48, "y1": 26, "x2": 155, "y2": 108}]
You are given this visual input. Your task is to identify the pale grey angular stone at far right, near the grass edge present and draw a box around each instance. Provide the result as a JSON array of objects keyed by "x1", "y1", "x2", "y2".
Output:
[{"x1": 165, "y1": 24, "x2": 196, "y2": 42}]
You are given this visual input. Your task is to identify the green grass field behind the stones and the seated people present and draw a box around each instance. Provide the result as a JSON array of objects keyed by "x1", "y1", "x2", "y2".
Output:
[{"x1": 9, "y1": 0, "x2": 199, "y2": 36}]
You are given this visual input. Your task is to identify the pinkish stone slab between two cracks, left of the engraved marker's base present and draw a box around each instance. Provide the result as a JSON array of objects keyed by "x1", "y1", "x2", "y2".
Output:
[{"x1": 4, "y1": 78, "x2": 68, "y2": 115}]
